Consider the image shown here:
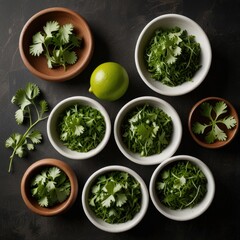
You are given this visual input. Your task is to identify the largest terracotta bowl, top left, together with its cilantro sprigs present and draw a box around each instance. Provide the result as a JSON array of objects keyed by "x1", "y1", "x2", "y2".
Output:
[{"x1": 19, "y1": 7, "x2": 94, "y2": 81}]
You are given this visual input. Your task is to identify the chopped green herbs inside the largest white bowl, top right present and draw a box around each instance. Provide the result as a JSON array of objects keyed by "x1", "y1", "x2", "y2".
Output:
[{"x1": 145, "y1": 27, "x2": 201, "y2": 86}]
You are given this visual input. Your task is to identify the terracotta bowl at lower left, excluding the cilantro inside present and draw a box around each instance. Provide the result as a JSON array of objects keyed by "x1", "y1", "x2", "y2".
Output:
[{"x1": 21, "y1": 158, "x2": 78, "y2": 217}]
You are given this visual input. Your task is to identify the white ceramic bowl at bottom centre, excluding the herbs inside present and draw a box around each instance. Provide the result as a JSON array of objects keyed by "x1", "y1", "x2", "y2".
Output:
[{"x1": 82, "y1": 165, "x2": 149, "y2": 233}]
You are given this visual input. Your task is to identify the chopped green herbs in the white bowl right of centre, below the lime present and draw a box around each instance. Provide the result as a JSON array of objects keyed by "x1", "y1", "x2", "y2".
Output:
[{"x1": 121, "y1": 104, "x2": 173, "y2": 156}]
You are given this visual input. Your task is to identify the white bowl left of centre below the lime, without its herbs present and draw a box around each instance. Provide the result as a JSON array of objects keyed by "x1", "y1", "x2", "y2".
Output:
[{"x1": 47, "y1": 96, "x2": 111, "y2": 160}]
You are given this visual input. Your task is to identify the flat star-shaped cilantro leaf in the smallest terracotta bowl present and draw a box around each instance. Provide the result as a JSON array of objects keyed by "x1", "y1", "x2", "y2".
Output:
[{"x1": 192, "y1": 101, "x2": 237, "y2": 143}]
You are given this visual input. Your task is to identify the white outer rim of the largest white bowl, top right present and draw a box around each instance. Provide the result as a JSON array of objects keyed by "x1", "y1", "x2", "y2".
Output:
[{"x1": 134, "y1": 13, "x2": 212, "y2": 96}]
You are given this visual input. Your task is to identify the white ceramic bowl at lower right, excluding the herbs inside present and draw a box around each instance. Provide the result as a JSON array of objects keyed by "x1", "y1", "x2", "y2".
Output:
[{"x1": 149, "y1": 155, "x2": 215, "y2": 221}]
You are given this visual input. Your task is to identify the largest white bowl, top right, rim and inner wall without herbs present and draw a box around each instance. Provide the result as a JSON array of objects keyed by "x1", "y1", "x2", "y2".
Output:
[{"x1": 135, "y1": 14, "x2": 212, "y2": 96}]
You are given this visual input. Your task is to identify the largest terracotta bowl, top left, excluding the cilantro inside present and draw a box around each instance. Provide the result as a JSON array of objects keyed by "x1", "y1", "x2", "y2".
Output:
[{"x1": 19, "y1": 7, "x2": 94, "y2": 82}]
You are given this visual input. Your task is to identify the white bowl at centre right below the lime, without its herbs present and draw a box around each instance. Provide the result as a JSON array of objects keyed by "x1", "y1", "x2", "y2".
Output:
[{"x1": 114, "y1": 96, "x2": 182, "y2": 165}]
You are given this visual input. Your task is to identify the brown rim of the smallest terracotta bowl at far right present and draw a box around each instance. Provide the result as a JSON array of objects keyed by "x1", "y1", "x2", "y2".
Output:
[{"x1": 188, "y1": 97, "x2": 239, "y2": 149}]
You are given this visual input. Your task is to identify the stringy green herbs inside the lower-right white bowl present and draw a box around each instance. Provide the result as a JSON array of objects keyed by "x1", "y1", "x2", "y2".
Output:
[{"x1": 156, "y1": 161, "x2": 207, "y2": 210}]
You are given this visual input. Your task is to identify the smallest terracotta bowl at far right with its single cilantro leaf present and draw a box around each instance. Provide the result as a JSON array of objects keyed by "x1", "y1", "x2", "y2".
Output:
[{"x1": 188, "y1": 97, "x2": 239, "y2": 148}]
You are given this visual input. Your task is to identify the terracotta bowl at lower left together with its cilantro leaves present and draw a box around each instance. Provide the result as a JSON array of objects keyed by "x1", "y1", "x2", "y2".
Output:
[{"x1": 21, "y1": 158, "x2": 78, "y2": 216}]
